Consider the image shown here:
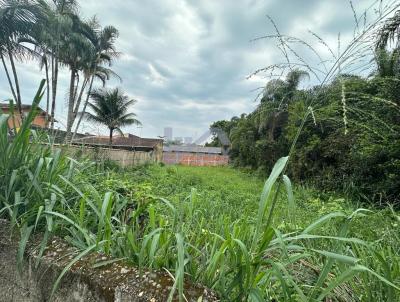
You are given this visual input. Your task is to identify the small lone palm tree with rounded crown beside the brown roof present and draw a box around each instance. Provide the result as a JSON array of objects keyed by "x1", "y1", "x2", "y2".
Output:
[{"x1": 82, "y1": 88, "x2": 141, "y2": 146}]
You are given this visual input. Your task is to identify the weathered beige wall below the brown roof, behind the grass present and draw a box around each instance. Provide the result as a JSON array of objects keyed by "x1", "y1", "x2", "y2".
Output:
[{"x1": 67, "y1": 146, "x2": 162, "y2": 167}]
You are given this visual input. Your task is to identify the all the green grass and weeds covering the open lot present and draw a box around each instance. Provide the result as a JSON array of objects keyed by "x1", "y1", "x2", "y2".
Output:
[{"x1": 0, "y1": 93, "x2": 400, "y2": 301}]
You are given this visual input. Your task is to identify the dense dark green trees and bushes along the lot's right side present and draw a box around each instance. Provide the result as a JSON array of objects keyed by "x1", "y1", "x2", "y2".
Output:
[{"x1": 212, "y1": 72, "x2": 400, "y2": 205}]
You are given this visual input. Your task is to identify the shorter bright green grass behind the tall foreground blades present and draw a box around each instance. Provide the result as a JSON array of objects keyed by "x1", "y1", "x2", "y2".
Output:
[{"x1": 105, "y1": 165, "x2": 399, "y2": 245}]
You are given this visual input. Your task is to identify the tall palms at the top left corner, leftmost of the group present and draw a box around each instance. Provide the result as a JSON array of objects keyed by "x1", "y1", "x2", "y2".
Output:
[{"x1": 0, "y1": 0, "x2": 83, "y2": 128}]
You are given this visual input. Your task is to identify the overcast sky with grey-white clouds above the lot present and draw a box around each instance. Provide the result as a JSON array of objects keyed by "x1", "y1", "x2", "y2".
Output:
[{"x1": 0, "y1": 0, "x2": 382, "y2": 137}]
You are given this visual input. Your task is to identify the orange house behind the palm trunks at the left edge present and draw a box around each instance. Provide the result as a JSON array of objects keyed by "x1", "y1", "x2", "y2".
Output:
[{"x1": 0, "y1": 103, "x2": 50, "y2": 129}]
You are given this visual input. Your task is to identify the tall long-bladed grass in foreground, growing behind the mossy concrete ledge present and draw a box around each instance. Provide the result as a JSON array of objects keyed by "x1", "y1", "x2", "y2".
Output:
[{"x1": 0, "y1": 92, "x2": 399, "y2": 301}]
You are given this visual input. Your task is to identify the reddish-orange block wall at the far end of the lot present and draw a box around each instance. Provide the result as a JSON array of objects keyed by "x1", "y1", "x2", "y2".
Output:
[{"x1": 163, "y1": 152, "x2": 229, "y2": 166}]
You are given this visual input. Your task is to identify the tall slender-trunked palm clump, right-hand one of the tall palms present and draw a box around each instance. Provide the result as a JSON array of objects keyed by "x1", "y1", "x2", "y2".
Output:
[{"x1": 32, "y1": 0, "x2": 118, "y2": 133}]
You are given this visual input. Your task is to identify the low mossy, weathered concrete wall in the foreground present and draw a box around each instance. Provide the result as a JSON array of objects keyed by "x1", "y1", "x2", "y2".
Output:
[{"x1": 0, "y1": 220, "x2": 218, "y2": 302}]
